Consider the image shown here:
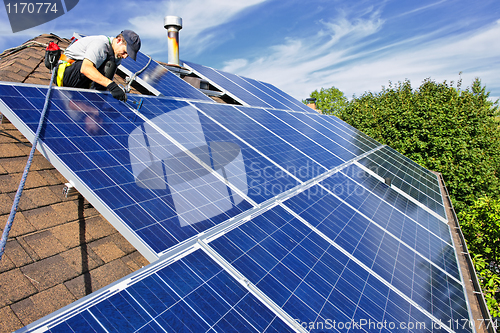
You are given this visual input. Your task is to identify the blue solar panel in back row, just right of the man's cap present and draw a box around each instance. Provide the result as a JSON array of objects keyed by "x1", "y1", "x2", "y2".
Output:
[{"x1": 119, "y1": 52, "x2": 211, "y2": 101}]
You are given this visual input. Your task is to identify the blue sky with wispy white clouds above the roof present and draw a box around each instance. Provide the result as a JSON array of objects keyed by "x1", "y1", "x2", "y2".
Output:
[{"x1": 0, "y1": 0, "x2": 500, "y2": 99}]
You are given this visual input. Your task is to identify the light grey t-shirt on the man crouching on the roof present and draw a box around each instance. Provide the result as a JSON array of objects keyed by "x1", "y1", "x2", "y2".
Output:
[{"x1": 64, "y1": 36, "x2": 121, "y2": 68}]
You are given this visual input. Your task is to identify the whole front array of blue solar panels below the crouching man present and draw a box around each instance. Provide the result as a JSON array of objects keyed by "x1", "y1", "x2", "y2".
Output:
[{"x1": 0, "y1": 78, "x2": 473, "y2": 332}]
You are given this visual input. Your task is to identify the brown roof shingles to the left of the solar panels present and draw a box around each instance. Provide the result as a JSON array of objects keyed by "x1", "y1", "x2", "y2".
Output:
[{"x1": 0, "y1": 35, "x2": 149, "y2": 332}]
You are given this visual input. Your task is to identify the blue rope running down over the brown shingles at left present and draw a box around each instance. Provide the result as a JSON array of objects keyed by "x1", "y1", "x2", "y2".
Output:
[{"x1": 0, "y1": 70, "x2": 55, "y2": 260}]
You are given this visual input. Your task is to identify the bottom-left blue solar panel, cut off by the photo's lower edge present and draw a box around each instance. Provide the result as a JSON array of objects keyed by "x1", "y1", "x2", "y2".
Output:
[{"x1": 35, "y1": 250, "x2": 293, "y2": 333}]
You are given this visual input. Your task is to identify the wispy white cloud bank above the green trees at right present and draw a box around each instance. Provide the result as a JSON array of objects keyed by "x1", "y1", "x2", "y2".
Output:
[{"x1": 223, "y1": 15, "x2": 500, "y2": 99}]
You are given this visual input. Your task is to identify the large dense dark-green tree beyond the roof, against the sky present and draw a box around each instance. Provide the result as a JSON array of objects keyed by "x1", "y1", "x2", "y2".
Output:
[{"x1": 338, "y1": 79, "x2": 500, "y2": 211}]
